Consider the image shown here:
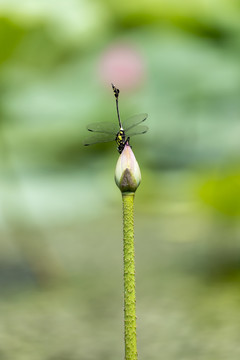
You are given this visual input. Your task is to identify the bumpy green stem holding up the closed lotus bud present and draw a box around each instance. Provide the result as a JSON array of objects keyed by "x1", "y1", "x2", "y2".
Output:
[{"x1": 122, "y1": 193, "x2": 137, "y2": 360}]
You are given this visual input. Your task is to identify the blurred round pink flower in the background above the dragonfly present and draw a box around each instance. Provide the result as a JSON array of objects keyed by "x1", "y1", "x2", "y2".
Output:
[{"x1": 99, "y1": 44, "x2": 145, "y2": 89}]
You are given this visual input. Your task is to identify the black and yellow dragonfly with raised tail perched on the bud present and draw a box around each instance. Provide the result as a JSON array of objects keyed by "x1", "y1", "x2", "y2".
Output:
[{"x1": 84, "y1": 84, "x2": 148, "y2": 154}]
